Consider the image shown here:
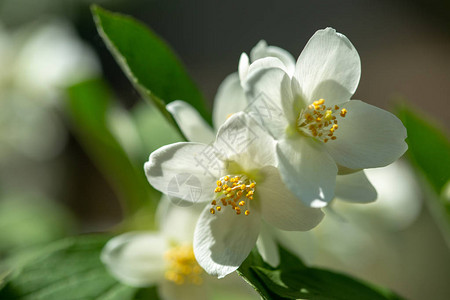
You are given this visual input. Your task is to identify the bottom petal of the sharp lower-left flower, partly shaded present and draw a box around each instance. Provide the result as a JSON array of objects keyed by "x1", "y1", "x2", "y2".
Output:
[{"x1": 194, "y1": 207, "x2": 261, "y2": 278}]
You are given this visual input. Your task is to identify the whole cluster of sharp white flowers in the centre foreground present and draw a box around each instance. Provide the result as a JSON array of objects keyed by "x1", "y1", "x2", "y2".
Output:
[{"x1": 105, "y1": 28, "x2": 407, "y2": 298}]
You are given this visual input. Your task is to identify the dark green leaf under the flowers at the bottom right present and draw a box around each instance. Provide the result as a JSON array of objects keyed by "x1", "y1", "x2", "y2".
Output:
[{"x1": 238, "y1": 247, "x2": 401, "y2": 300}]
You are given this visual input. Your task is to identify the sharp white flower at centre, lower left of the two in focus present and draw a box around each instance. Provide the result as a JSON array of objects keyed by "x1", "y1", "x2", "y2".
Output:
[{"x1": 145, "y1": 112, "x2": 323, "y2": 278}]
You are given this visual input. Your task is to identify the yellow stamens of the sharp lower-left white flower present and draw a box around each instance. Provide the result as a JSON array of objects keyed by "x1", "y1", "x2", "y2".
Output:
[{"x1": 210, "y1": 175, "x2": 256, "y2": 216}]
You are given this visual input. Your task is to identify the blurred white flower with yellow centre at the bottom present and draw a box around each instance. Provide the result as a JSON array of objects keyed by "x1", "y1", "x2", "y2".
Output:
[{"x1": 101, "y1": 197, "x2": 252, "y2": 300}]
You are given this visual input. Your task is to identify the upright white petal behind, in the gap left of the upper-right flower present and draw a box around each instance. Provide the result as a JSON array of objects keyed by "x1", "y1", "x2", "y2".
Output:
[{"x1": 213, "y1": 73, "x2": 247, "y2": 130}]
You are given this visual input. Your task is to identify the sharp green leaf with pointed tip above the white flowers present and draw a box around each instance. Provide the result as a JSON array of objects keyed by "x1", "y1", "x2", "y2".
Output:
[{"x1": 92, "y1": 5, "x2": 211, "y2": 128}]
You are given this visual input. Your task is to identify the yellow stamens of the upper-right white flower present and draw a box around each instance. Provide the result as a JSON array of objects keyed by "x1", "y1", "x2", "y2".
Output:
[{"x1": 297, "y1": 99, "x2": 347, "y2": 143}]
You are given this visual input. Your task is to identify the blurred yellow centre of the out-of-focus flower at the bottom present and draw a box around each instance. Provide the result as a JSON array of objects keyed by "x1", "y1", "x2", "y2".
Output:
[{"x1": 164, "y1": 245, "x2": 203, "y2": 285}]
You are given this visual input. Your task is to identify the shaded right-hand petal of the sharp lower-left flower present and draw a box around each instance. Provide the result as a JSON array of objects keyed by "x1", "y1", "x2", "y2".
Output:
[{"x1": 255, "y1": 167, "x2": 323, "y2": 231}]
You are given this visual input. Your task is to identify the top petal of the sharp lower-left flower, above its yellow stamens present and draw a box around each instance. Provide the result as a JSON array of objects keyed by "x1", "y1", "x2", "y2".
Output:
[{"x1": 214, "y1": 112, "x2": 276, "y2": 170}]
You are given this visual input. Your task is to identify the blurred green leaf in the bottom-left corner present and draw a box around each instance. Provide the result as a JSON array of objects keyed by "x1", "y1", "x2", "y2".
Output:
[{"x1": 0, "y1": 236, "x2": 159, "y2": 300}]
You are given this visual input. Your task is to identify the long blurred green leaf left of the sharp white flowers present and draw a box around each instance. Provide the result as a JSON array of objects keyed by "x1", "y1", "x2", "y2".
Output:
[{"x1": 67, "y1": 79, "x2": 159, "y2": 219}]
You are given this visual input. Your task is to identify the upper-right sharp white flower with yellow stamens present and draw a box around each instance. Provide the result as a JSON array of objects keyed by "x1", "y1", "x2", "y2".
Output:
[{"x1": 243, "y1": 28, "x2": 407, "y2": 207}]
